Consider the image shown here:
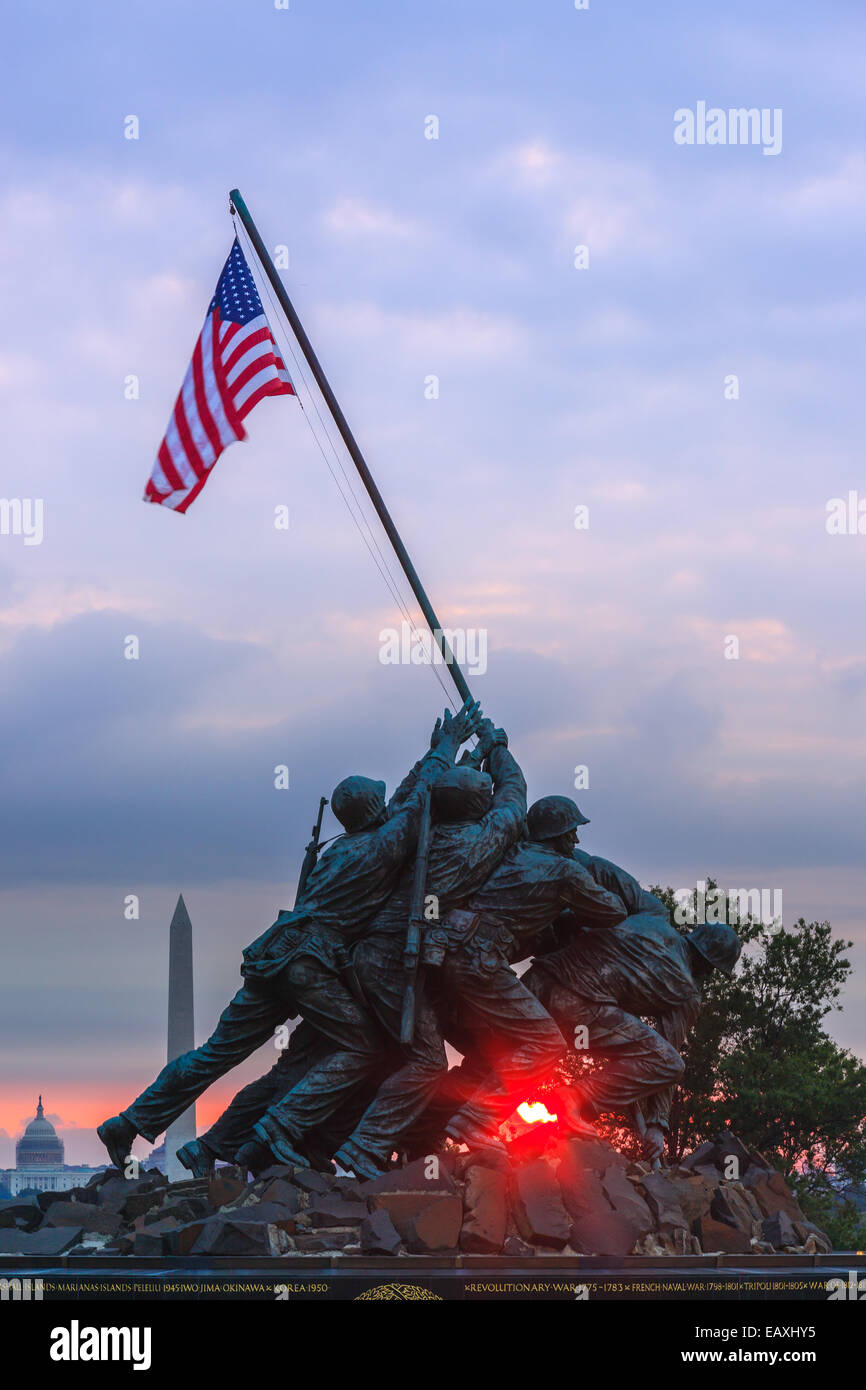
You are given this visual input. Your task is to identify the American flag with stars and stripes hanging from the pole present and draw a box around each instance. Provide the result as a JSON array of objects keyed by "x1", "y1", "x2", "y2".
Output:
[{"x1": 145, "y1": 238, "x2": 295, "y2": 512}]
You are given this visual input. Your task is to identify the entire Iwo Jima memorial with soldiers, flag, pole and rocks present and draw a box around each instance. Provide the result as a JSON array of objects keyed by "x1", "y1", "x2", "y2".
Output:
[{"x1": 83, "y1": 190, "x2": 828, "y2": 1255}]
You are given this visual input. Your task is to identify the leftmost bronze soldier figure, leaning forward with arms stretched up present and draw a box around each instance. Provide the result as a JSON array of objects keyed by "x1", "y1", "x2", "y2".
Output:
[{"x1": 97, "y1": 701, "x2": 481, "y2": 1166}]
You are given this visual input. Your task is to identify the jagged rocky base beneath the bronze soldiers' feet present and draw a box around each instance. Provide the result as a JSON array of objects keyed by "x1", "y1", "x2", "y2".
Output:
[{"x1": 0, "y1": 1133, "x2": 831, "y2": 1258}]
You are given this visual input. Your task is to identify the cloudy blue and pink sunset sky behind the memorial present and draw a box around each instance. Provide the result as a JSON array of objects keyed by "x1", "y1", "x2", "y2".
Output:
[{"x1": 0, "y1": 0, "x2": 866, "y2": 1166}]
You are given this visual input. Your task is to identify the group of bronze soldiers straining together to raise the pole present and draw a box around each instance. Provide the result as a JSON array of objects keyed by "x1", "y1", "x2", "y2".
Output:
[{"x1": 99, "y1": 728, "x2": 740, "y2": 1176}]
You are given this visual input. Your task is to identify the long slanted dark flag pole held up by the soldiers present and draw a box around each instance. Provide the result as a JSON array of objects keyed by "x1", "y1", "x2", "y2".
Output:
[{"x1": 229, "y1": 188, "x2": 473, "y2": 701}]
